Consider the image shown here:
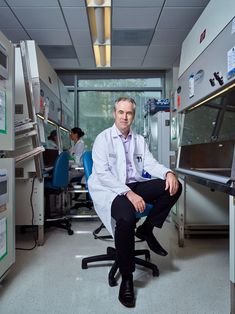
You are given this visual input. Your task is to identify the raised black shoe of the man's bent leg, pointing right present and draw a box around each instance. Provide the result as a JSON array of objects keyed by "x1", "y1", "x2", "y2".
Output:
[{"x1": 135, "y1": 226, "x2": 168, "y2": 256}]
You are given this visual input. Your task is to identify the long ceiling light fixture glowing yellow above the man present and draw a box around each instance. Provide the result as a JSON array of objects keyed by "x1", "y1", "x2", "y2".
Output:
[{"x1": 86, "y1": 0, "x2": 111, "y2": 67}]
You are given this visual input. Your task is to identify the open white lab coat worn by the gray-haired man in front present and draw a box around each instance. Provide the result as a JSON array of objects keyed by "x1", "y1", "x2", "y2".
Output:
[{"x1": 88, "y1": 125, "x2": 171, "y2": 236}]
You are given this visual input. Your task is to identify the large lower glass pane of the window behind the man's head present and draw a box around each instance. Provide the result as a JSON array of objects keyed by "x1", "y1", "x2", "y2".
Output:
[{"x1": 79, "y1": 91, "x2": 161, "y2": 149}]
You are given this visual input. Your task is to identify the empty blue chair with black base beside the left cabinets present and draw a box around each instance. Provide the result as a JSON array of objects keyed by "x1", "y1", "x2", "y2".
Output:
[{"x1": 44, "y1": 152, "x2": 73, "y2": 235}]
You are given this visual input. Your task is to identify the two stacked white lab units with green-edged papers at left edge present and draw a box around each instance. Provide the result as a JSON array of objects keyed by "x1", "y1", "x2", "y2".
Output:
[{"x1": 0, "y1": 32, "x2": 15, "y2": 281}]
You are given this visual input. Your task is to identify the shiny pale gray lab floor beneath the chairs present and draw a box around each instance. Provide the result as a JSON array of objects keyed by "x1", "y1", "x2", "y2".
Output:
[{"x1": 0, "y1": 220, "x2": 229, "y2": 314}]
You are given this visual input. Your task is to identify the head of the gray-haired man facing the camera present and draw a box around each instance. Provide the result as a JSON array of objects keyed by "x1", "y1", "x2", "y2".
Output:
[{"x1": 113, "y1": 100, "x2": 135, "y2": 135}]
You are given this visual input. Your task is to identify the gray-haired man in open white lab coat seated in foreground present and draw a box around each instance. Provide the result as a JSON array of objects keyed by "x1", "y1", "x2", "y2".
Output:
[{"x1": 88, "y1": 97, "x2": 182, "y2": 307}]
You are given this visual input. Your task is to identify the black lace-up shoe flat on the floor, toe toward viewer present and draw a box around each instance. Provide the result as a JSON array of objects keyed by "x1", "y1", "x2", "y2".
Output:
[{"x1": 118, "y1": 275, "x2": 135, "y2": 307}]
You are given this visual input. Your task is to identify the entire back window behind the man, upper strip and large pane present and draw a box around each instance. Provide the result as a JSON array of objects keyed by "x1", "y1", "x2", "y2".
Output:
[{"x1": 78, "y1": 78, "x2": 163, "y2": 149}]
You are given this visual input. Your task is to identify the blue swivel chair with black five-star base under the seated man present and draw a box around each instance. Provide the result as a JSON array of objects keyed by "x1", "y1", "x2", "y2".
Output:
[{"x1": 81, "y1": 151, "x2": 159, "y2": 287}]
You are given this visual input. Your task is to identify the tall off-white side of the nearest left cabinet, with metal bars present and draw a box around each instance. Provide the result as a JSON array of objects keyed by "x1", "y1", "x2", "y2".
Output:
[{"x1": 11, "y1": 42, "x2": 44, "y2": 244}]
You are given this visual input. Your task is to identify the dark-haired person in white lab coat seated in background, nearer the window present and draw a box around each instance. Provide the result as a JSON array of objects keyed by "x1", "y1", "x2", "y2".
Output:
[{"x1": 69, "y1": 127, "x2": 85, "y2": 181}]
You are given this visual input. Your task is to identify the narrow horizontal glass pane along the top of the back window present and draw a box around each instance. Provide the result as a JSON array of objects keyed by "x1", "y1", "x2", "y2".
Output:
[{"x1": 78, "y1": 78, "x2": 163, "y2": 89}]
